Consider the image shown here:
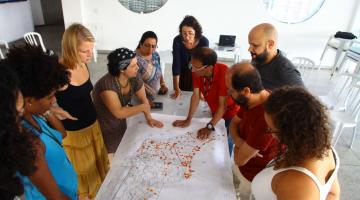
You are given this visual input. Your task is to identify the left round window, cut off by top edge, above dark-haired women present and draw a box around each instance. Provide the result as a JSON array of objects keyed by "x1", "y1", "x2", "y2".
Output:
[{"x1": 119, "y1": 0, "x2": 167, "y2": 14}]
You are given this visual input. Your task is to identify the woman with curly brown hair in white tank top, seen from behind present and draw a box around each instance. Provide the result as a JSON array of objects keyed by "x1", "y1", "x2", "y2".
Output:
[{"x1": 252, "y1": 87, "x2": 340, "y2": 200}]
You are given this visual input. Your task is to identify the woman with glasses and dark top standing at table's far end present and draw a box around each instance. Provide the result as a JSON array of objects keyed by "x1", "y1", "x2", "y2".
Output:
[{"x1": 171, "y1": 15, "x2": 209, "y2": 98}]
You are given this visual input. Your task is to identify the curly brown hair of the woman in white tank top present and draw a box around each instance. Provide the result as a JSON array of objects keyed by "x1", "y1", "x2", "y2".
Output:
[{"x1": 264, "y1": 86, "x2": 331, "y2": 167}]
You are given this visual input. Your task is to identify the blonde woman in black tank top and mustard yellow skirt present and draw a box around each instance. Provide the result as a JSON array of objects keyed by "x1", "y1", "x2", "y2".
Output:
[{"x1": 56, "y1": 24, "x2": 109, "y2": 198}]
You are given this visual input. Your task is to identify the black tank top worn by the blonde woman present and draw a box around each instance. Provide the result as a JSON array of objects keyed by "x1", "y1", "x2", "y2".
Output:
[{"x1": 56, "y1": 78, "x2": 96, "y2": 131}]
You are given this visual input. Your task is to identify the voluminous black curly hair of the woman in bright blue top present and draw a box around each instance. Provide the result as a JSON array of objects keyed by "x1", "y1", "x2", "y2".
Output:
[{"x1": 7, "y1": 45, "x2": 70, "y2": 99}]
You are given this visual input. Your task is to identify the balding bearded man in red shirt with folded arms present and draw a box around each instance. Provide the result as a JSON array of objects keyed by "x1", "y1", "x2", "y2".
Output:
[{"x1": 226, "y1": 62, "x2": 278, "y2": 198}]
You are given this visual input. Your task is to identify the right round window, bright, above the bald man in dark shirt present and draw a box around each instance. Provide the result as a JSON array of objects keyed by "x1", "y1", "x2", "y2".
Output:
[{"x1": 263, "y1": 0, "x2": 325, "y2": 24}]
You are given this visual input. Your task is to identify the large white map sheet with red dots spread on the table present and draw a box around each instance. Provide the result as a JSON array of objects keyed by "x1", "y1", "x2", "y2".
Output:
[{"x1": 96, "y1": 114, "x2": 236, "y2": 200}]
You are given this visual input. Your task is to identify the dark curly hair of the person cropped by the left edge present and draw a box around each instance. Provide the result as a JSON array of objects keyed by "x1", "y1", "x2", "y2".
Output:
[{"x1": 0, "y1": 61, "x2": 36, "y2": 200}]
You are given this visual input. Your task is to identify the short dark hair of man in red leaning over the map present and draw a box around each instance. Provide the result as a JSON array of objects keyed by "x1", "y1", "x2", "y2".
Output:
[{"x1": 191, "y1": 47, "x2": 217, "y2": 66}]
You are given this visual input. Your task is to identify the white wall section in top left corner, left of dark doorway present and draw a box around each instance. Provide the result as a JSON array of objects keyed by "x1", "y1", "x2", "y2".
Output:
[{"x1": 0, "y1": 1, "x2": 34, "y2": 42}]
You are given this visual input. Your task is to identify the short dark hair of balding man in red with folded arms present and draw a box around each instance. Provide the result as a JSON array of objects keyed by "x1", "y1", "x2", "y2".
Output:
[{"x1": 231, "y1": 63, "x2": 264, "y2": 93}]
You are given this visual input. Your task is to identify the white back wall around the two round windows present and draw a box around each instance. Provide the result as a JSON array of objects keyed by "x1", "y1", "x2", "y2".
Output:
[{"x1": 62, "y1": 0, "x2": 357, "y2": 61}]
